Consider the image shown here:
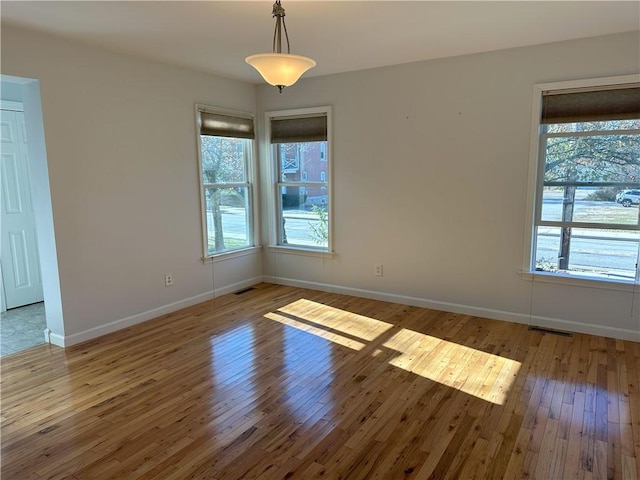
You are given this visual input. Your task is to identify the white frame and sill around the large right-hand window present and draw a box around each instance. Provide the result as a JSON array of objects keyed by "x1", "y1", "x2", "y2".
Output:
[{"x1": 520, "y1": 75, "x2": 640, "y2": 292}]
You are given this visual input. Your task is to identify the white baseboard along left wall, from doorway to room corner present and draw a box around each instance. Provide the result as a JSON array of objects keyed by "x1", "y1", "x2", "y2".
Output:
[{"x1": 55, "y1": 277, "x2": 262, "y2": 347}]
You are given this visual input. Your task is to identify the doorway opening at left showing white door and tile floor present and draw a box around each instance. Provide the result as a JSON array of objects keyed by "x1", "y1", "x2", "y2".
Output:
[{"x1": 0, "y1": 75, "x2": 64, "y2": 355}]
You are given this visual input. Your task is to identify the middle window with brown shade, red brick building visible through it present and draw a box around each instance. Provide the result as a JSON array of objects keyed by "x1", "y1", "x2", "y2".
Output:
[{"x1": 267, "y1": 107, "x2": 331, "y2": 251}]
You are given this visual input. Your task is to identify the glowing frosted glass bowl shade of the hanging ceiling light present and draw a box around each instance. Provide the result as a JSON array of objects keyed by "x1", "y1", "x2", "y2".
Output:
[{"x1": 245, "y1": 53, "x2": 316, "y2": 87}]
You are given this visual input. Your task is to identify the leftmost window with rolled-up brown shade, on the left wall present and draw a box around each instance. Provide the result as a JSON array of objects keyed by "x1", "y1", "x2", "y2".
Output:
[{"x1": 197, "y1": 106, "x2": 255, "y2": 258}]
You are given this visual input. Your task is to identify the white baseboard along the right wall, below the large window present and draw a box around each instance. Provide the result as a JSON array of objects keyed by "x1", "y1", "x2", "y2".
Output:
[{"x1": 262, "y1": 275, "x2": 640, "y2": 342}]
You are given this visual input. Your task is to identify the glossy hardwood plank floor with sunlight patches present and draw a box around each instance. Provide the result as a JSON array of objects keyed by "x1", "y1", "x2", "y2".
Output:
[{"x1": 1, "y1": 284, "x2": 640, "y2": 480}]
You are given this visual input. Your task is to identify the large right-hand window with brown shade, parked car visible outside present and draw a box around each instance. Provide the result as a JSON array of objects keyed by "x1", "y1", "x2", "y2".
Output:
[{"x1": 529, "y1": 77, "x2": 640, "y2": 283}]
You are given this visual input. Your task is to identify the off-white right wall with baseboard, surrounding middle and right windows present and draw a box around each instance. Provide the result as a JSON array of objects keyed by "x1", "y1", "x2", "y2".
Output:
[{"x1": 257, "y1": 32, "x2": 640, "y2": 341}]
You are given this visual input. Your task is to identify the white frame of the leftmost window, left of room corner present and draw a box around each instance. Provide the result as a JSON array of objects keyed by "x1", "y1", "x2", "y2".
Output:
[{"x1": 195, "y1": 104, "x2": 260, "y2": 264}]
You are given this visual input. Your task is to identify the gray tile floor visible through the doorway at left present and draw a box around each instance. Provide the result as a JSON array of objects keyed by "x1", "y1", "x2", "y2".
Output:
[{"x1": 0, "y1": 302, "x2": 47, "y2": 357}]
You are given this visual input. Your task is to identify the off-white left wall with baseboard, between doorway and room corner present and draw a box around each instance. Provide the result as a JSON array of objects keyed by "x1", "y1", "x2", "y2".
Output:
[{"x1": 2, "y1": 25, "x2": 261, "y2": 345}]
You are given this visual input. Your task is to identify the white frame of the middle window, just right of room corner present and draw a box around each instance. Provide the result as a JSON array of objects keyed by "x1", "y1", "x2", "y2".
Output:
[{"x1": 265, "y1": 106, "x2": 334, "y2": 257}]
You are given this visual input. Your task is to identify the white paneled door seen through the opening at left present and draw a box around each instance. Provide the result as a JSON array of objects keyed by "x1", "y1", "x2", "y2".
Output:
[{"x1": 0, "y1": 110, "x2": 43, "y2": 308}]
